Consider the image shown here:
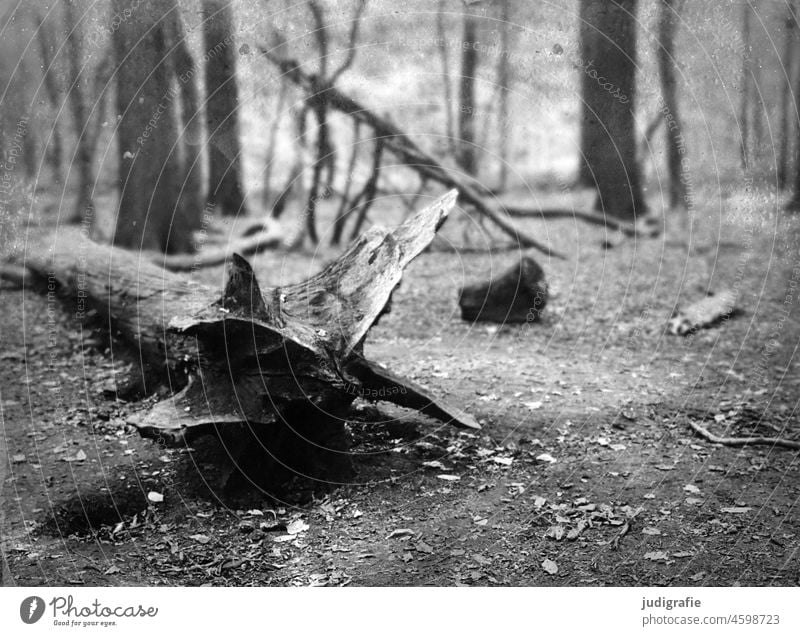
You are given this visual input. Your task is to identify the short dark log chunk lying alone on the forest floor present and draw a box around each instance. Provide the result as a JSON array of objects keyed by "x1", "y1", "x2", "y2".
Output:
[{"x1": 458, "y1": 256, "x2": 548, "y2": 324}]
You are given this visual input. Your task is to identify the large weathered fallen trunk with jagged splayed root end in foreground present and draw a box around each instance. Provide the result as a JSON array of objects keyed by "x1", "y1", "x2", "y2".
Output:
[{"x1": 14, "y1": 192, "x2": 480, "y2": 482}]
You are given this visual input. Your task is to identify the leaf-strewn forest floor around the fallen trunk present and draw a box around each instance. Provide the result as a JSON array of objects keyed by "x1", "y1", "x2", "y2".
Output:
[{"x1": 0, "y1": 180, "x2": 800, "y2": 586}]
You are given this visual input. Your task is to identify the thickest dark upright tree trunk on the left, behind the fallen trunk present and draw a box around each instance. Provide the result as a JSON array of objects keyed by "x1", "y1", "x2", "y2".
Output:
[{"x1": 113, "y1": 0, "x2": 202, "y2": 253}]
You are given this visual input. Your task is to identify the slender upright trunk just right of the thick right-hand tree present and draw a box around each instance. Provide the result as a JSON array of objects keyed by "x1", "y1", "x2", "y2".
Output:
[{"x1": 656, "y1": 0, "x2": 687, "y2": 209}]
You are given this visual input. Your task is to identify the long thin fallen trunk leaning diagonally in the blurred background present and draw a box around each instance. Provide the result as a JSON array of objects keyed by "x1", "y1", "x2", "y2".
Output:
[{"x1": 261, "y1": 47, "x2": 564, "y2": 259}]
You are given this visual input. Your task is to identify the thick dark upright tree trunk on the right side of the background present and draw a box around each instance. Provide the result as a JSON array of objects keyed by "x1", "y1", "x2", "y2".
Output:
[{"x1": 579, "y1": 0, "x2": 646, "y2": 218}]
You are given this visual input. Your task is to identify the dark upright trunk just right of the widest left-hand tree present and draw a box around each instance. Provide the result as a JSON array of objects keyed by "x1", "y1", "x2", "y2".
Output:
[{"x1": 203, "y1": 0, "x2": 244, "y2": 215}]
